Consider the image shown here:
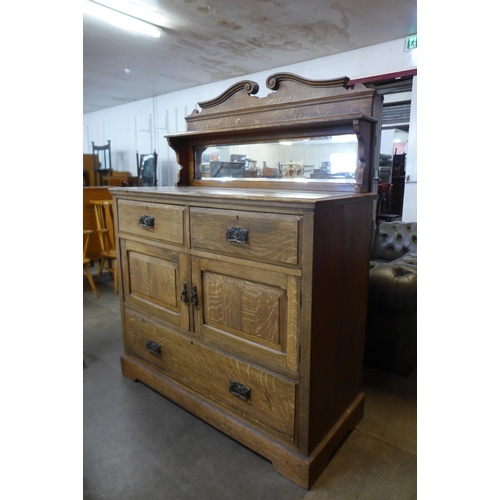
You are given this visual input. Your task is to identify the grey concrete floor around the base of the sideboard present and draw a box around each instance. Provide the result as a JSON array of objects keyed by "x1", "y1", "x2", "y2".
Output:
[{"x1": 83, "y1": 265, "x2": 417, "y2": 500}]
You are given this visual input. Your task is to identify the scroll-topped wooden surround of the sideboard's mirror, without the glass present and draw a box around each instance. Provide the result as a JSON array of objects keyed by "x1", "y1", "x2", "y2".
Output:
[{"x1": 166, "y1": 73, "x2": 382, "y2": 193}]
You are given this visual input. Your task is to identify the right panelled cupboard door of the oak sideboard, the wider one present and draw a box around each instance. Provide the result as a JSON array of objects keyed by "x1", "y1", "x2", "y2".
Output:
[{"x1": 192, "y1": 257, "x2": 300, "y2": 372}]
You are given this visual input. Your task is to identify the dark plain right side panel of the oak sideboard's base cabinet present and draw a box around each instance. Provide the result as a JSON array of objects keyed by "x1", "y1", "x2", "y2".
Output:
[{"x1": 308, "y1": 202, "x2": 372, "y2": 452}]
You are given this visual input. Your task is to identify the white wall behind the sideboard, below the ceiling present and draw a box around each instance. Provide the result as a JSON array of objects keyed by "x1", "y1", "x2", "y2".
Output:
[{"x1": 83, "y1": 39, "x2": 417, "y2": 220}]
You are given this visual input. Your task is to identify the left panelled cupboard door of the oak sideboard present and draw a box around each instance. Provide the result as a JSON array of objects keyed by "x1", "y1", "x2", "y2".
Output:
[{"x1": 120, "y1": 239, "x2": 189, "y2": 329}]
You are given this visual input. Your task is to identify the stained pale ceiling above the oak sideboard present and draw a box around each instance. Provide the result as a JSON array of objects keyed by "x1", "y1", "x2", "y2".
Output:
[{"x1": 83, "y1": 0, "x2": 417, "y2": 113}]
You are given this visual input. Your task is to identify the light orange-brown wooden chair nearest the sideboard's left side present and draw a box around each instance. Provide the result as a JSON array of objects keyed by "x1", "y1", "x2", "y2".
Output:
[{"x1": 90, "y1": 200, "x2": 118, "y2": 293}]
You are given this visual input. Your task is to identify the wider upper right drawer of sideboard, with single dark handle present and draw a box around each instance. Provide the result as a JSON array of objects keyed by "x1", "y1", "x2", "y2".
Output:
[{"x1": 190, "y1": 207, "x2": 300, "y2": 265}]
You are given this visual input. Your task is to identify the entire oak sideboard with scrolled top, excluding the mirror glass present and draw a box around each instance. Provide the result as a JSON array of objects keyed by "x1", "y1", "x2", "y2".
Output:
[{"x1": 110, "y1": 73, "x2": 381, "y2": 489}]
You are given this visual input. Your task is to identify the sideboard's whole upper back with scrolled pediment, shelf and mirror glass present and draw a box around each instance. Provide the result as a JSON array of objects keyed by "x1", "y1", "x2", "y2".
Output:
[{"x1": 167, "y1": 73, "x2": 381, "y2": 193}]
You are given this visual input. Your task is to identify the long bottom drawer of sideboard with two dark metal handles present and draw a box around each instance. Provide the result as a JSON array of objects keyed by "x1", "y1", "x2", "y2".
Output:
[{"x1": 125, "y1": 311, "x2": 297, "y2": 443}]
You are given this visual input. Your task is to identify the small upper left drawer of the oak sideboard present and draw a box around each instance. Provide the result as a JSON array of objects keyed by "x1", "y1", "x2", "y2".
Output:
[{"x1": 118, "y1": 200, "x2": 186, "y2": 245}]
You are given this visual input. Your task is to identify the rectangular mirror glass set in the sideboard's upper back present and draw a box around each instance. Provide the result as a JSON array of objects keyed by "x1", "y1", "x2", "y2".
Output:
[{"x1": 195, "y1": 134, "x2": 358, "y2": 183}]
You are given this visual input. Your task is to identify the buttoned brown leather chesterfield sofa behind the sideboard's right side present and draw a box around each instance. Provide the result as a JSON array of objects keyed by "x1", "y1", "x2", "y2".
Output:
[{"x1": 365, "y1": 222, "x2": 417, "y2": 376}]
